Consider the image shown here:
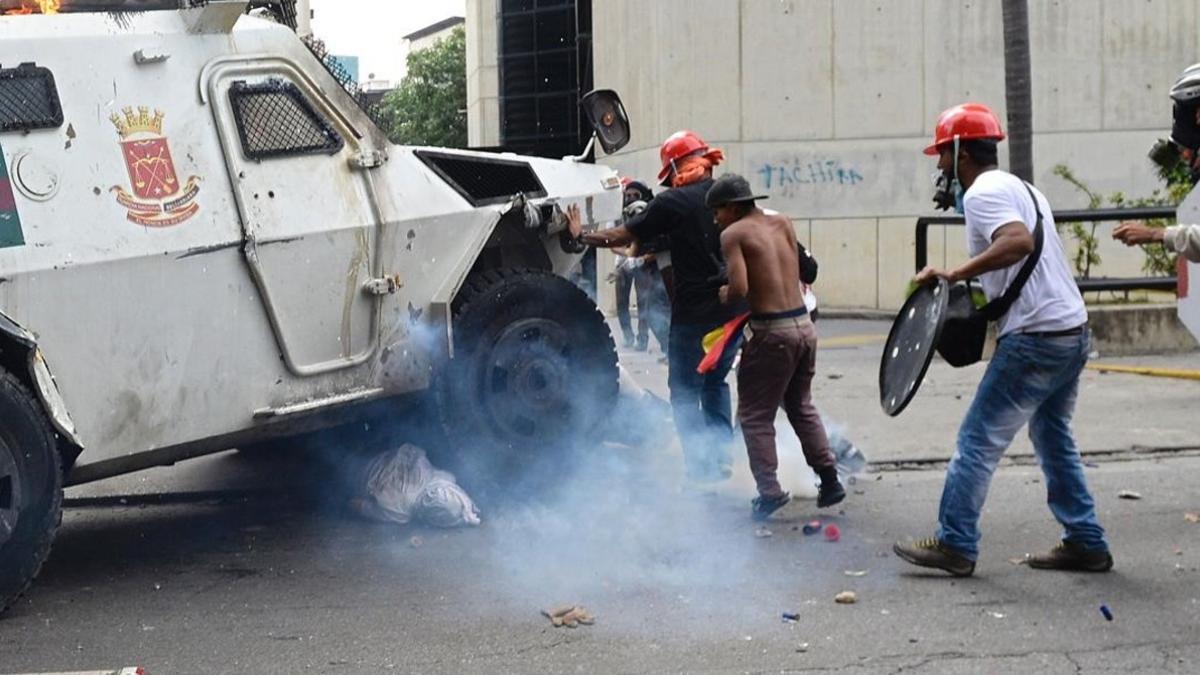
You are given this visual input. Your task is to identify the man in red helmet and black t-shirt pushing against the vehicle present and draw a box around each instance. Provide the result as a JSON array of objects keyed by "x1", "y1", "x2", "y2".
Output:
[{"x1": 572, "y1": 131, "x2": 742, "y2": 483}]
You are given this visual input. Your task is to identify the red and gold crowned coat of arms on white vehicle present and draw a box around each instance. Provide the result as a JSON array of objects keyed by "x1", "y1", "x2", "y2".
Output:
[{"x1": 109, "y1": 106, "x2": 200, "y2": 227}]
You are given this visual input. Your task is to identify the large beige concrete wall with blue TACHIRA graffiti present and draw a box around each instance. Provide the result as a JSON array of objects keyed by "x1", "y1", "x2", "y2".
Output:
[{"x1": 590, "y1": 0, "x2": 1200, "y2": 309}]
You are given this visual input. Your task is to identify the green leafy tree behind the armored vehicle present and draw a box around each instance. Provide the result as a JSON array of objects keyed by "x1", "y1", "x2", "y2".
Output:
[{"x1": 379, "y1": 26, "x2": 467, "y2": 148}]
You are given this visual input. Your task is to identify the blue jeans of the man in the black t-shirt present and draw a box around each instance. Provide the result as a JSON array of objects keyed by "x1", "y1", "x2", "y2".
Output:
[{"x1": 667, "y1": 322, "x2": 737, "y2": 480}]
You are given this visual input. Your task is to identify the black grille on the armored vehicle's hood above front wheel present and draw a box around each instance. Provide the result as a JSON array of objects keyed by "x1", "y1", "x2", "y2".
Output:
[{"x1": 415, "y1": 150, "x2": 546, "y2": 207}]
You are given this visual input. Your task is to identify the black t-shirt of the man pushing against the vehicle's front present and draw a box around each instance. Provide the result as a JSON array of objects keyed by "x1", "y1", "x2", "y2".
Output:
[{"x1": 625, "y1": 179, "x2": 744, "y2": 324}]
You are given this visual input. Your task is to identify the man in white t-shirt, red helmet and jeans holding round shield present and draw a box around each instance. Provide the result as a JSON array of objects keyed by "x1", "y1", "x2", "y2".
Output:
[{"x1": 893, "y1": 103, "x2": 1112, "y2": 577}]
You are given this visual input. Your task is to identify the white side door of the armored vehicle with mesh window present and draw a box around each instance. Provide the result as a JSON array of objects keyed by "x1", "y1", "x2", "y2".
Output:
[{"x1": 208, "y1": 59, "x2": 379, "y2": 376}]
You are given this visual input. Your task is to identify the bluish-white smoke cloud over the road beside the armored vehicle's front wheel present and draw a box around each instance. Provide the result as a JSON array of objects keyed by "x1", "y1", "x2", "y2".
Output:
[{"x1": 338, "y1": 309, "x2": 864, "y2": 607}]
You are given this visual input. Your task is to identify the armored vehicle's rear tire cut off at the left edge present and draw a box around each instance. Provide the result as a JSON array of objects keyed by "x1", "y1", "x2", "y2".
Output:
[{"x1": 0, "y1": 369, "x2": 62, "y2": 611}]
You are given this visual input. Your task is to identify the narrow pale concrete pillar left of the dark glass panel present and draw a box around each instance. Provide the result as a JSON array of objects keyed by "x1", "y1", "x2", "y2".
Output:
[{"x1": 466, "y1": 0, "x2": 500, "y2": 148}]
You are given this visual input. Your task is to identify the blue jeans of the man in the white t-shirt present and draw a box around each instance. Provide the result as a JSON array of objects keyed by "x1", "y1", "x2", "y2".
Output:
[{"x1": 937, "y1": 329, "x2": 1109, "y2": 560}]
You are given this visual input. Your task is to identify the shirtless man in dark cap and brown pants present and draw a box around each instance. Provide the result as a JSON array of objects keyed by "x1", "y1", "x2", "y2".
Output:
[{"x1": 706, "y1": 174, "x2": 846, "y2": 520}]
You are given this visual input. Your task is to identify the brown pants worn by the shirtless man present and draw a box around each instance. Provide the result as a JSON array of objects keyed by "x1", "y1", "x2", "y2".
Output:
[{"x1": 738, "y1": 316, "x2": 835, "y2": 497}]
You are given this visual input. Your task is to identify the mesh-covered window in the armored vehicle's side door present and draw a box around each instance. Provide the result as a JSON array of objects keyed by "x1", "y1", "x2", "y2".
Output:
[{"x1": 229, "y1": 79, "x2": 343, "y2": 160}]
